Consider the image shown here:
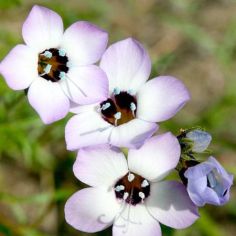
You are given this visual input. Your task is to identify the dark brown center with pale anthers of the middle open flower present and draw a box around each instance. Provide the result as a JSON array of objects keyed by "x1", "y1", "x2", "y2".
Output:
[{"x1": 100, "y1": 88, "x2": 137, "y2": 126}]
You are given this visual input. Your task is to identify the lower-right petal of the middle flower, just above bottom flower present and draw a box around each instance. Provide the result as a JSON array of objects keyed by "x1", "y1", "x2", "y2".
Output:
[{"x1": 110, "y1": 119, "x2": 158, "y2": 148}]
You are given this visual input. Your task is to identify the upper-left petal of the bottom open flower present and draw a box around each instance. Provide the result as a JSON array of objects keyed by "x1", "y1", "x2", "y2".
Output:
[{"x1": 73, "y1": 145, "x2": 128, "y2": 187}]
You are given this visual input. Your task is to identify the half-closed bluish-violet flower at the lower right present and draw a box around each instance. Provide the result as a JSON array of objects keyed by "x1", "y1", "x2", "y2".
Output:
[{"x1": 184, "y1": 157, "x2": 233, "y2": 206}]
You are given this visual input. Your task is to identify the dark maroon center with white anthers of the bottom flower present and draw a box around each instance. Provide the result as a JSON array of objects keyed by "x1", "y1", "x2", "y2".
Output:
[{"x1": 114, "y1": 172, "x2": 150, "y2": 205}]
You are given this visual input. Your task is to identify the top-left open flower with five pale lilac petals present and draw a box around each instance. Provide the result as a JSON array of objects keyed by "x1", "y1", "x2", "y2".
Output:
[{"x1": 0, "y1": 6, "x2": 108, "y2": 123}]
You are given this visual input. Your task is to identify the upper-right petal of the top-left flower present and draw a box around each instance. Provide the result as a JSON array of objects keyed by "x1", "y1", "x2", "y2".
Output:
[{"x1": 62, "y1": 21, "x2": 108, "y2": 65}]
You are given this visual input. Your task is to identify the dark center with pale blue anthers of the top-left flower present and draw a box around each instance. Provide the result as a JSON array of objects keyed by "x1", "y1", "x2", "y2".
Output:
[{"x1": 38, "y1": 48, "x2": 69, "y2": 82}]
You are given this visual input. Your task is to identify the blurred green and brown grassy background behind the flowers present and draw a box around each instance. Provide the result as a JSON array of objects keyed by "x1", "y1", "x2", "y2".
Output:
[{"x1": 0, "y1": 0, "x2": 236, "y2": 236}]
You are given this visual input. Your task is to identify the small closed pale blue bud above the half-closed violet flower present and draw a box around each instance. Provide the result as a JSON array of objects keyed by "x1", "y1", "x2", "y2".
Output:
[{"x1": 186, "y1": 129, "x2": 212, "y2": 153}]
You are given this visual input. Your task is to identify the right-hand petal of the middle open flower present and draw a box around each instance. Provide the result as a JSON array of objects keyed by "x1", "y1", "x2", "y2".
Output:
[{"x1": 137, "y1": 76, "x2": 190, "y2": 122}]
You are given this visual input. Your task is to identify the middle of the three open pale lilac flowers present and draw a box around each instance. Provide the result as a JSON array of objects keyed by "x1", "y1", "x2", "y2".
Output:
[{"x1": 65, "y1": 38, "x2": 189, "y2": 150}]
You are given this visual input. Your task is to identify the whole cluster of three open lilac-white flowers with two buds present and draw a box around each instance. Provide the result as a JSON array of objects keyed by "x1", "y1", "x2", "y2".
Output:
[{"x1": 0, "y1": 6, "x2": 233, "y2": 236}]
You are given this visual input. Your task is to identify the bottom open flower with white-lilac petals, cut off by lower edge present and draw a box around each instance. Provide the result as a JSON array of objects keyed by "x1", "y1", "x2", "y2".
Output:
[{"x1": 65, "y1": 133, "x2": 198, "y2": 236}]
